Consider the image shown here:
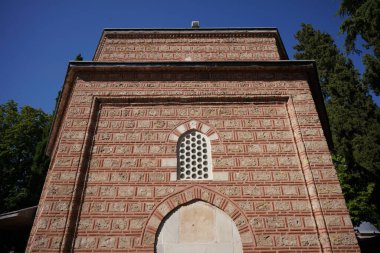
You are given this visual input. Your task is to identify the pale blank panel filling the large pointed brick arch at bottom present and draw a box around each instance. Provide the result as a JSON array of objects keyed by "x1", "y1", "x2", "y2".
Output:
[{"x1": 155, "y1": 201, "x2": 243, "y2": 253}]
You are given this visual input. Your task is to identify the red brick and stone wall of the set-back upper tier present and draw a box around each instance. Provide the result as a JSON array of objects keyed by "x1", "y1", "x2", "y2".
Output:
[{"x1": 94, "y1": 32, "x2": 280, "y2": 62}]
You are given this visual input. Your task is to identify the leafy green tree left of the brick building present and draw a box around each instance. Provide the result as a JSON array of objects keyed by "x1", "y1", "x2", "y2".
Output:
[{"x1": 0, "y1": 101, "x2": 51, "y2": 212}]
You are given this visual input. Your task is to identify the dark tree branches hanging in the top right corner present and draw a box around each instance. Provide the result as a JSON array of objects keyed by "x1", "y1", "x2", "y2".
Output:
[{"x1": 339, "y1": 0, "x2": 380, "y2": 95}]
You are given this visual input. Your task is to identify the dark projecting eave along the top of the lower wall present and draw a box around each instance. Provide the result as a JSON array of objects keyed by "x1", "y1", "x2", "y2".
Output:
[{"x1": 47, "y1": 61, "x2": 333, "y2": 155}]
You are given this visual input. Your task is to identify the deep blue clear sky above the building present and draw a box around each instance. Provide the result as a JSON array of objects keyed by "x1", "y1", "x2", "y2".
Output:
[{"x1": 0, "y1": 0, "x2": 380, "y2": 113}]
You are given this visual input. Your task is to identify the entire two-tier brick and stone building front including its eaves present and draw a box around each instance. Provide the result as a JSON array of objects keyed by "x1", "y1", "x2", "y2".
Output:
[{"x1": 27, "y1": 29, "x2": 359, "y2": 252}]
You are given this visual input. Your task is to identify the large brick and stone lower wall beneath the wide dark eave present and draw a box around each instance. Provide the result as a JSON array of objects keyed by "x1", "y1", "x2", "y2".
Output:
[{"x1": 28, "y1": 69, "x2": 358, "y2": 252}]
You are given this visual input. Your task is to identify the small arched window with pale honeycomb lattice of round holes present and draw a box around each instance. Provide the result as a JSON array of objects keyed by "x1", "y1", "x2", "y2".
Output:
[{"x1": 177, "y1": 131, "x2": 212, "y2": 180}]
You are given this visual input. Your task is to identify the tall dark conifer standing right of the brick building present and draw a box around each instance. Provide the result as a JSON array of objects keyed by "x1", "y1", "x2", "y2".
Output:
[{"x1": 294, "y1": 24, "x2": 380, "y2": 223}]
